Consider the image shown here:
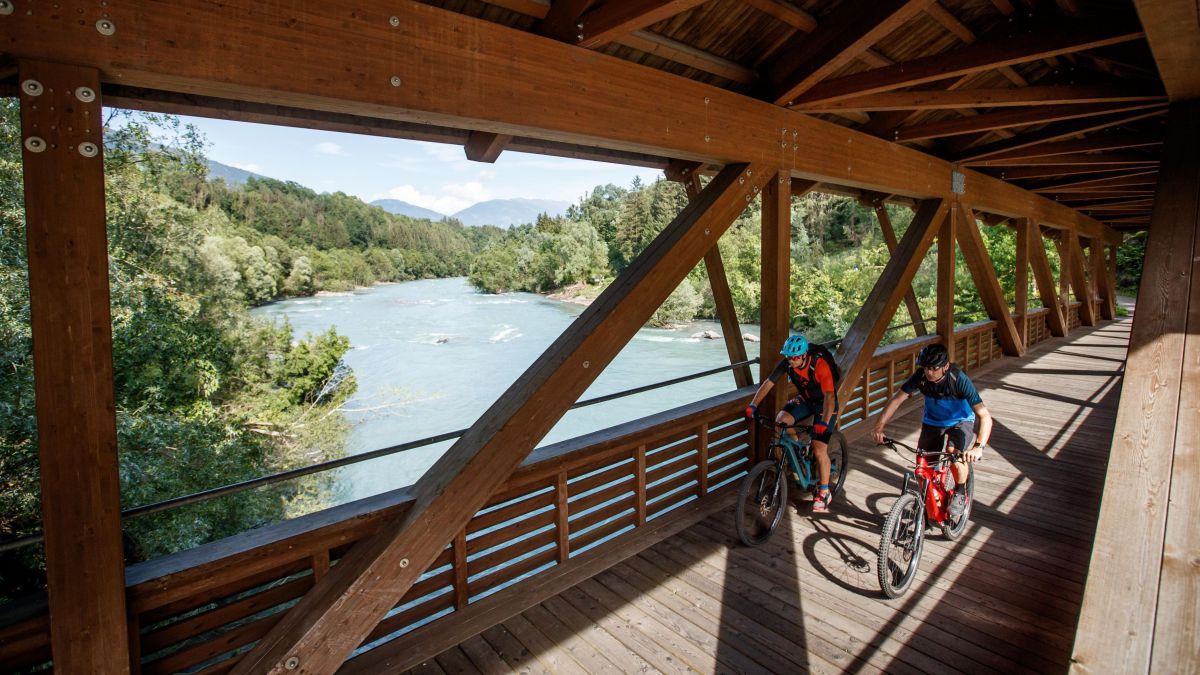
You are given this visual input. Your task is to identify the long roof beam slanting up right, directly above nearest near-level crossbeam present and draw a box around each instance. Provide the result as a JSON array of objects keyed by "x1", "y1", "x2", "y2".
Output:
[{"x1": 788, "y1": 20, "x2": 1144, "y2": 103}]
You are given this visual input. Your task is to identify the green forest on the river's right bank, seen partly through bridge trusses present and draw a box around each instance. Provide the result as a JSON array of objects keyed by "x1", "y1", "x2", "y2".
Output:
[{"x1": 470, "y1": 180, "x2": 1141, "y2": 341}]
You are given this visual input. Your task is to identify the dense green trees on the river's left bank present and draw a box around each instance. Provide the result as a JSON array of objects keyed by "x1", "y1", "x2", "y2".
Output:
[{"x1": 0, "y1": 105, "x2": 499, "y2": 599}]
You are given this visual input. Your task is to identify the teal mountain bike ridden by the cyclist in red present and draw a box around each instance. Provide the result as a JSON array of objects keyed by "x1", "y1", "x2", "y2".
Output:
[{"x1": 734, "y1": 416, "x2": 850, "y2": 546}]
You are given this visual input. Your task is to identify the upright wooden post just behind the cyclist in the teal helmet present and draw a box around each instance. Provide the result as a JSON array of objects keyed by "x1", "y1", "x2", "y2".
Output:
[{"x1": 758, "y1": 172, "x2": 792, "y2": 413}]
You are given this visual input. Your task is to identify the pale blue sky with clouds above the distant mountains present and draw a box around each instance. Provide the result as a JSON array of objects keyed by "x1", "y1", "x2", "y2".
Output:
[{"x1": 181, "y1": 117, "x2": 661, "y2": 214}]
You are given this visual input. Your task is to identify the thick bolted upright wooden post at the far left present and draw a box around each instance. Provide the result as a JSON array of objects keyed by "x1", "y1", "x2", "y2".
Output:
[{"x1": 19, "y1": 61, "x2": 130, "y2": 673}]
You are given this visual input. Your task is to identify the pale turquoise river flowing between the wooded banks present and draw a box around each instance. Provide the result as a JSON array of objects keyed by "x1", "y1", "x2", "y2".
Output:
[{"x1": 252, "y1": 277, "x2": 758, "y2": 503}]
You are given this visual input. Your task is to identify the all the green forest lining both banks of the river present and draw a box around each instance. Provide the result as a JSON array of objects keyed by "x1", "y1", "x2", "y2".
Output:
[{"x1": 0, "y1": 105, "x2": 1145, "y2": 601}]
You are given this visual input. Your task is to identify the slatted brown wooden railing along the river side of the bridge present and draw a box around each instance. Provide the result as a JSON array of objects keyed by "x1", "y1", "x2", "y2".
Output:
[{"x1": 0, "y1": 303, "x2": 1094, "y2": 674}]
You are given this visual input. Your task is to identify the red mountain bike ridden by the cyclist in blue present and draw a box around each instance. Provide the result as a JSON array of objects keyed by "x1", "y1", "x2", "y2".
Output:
[{"x1": 878, "y1": 437, "x2": 974, "y2": 598}]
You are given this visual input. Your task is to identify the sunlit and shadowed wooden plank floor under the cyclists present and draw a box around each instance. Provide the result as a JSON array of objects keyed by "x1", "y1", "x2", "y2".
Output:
[{"x1": 405, "y1": 319, "x2": 1129, "y2": 673}]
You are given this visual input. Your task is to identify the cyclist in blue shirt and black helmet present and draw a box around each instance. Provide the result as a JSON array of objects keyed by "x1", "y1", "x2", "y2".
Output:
[{"x1": 874, "y1": 345, "x2": 991, "y2": 518}]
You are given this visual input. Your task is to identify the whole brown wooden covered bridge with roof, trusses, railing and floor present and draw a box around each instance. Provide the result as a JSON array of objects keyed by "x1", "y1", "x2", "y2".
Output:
[{"x1": 0, "y1": 0, "x2": 1200, "y2": 673}]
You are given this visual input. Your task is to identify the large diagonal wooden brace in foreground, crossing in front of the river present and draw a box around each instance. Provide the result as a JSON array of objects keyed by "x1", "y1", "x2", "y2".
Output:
[{"x1": 233, "y1": 165, "x2": 776, "y2": 674}]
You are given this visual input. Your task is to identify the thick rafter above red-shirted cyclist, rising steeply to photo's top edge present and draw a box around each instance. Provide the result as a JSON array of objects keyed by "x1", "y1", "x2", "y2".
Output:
[{"x1": 767, "y1": 0, "x2": 931, "y2": 104}]
